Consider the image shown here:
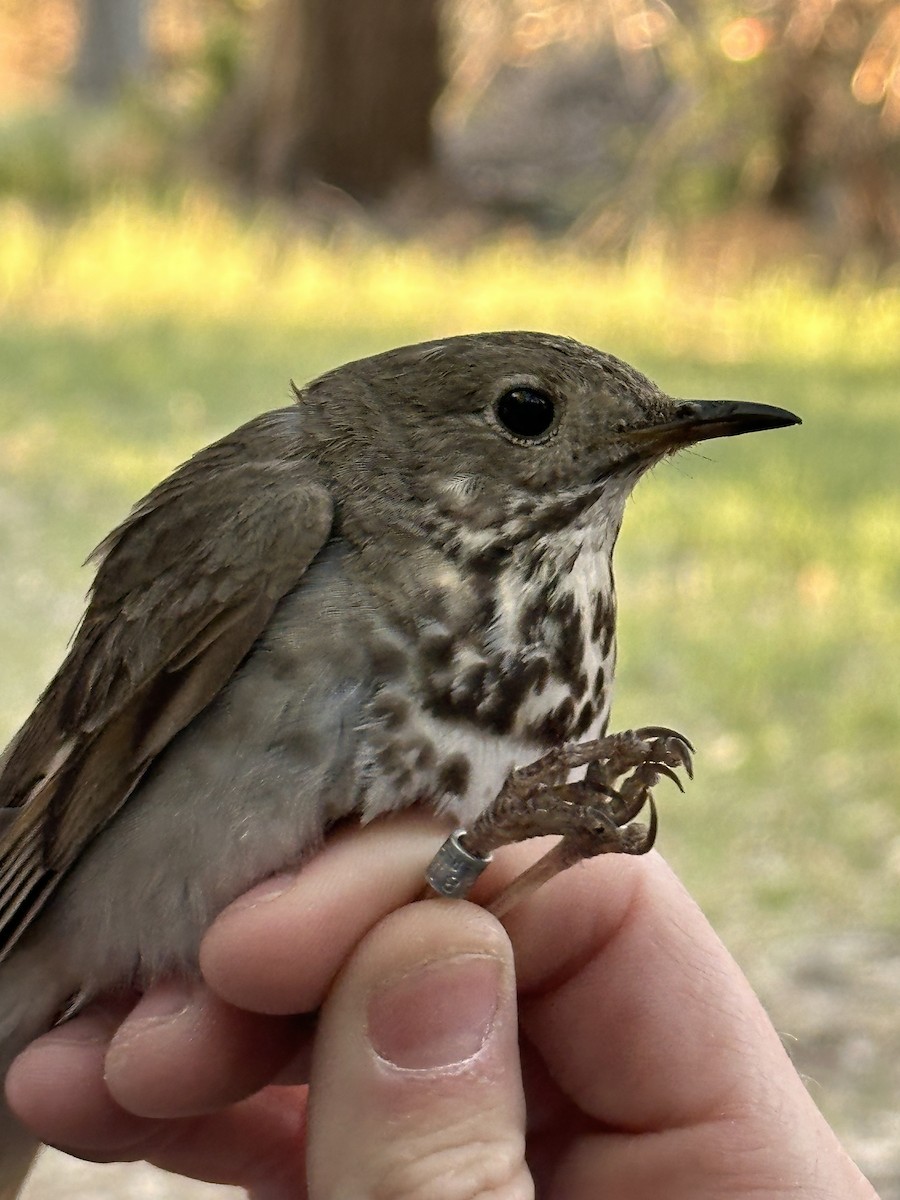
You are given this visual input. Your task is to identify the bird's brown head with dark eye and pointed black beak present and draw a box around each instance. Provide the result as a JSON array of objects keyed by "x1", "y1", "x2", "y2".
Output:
[{"x1": 301, "y1": 332, "x2": 799, "y2": 544}]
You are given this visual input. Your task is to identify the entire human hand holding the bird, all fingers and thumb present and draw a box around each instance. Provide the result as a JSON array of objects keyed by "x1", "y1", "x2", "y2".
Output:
[{"x1": 7, "y1": 814, "x2": 875, "y2": 1200}]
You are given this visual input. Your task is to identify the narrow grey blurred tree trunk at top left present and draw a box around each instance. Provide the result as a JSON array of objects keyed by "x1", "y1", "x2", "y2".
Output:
[{"x1": 70, "y1": 0, "x2": 148, "y2": 102}]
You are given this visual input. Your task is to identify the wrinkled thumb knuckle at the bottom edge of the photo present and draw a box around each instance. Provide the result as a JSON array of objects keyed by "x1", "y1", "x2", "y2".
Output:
[{"x1": 371, "y1": 1139, "x2": 534, "y2": 1200}]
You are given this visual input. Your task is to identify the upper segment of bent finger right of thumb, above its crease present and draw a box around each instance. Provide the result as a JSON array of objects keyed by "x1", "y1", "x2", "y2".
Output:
[{"x1": 510, "y1": 854, "x2": 801, "y2": 1129}]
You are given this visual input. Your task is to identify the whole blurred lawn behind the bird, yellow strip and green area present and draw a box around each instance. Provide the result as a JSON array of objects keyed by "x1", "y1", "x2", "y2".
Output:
[{"x1": 0, "y1": 189, "x2": 900, "y2": 952}]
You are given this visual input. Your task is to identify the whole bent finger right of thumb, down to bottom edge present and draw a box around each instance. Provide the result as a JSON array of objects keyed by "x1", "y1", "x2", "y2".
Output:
[{"x1": 494, "y1": 854, "x2": 870, "y2": 1200}]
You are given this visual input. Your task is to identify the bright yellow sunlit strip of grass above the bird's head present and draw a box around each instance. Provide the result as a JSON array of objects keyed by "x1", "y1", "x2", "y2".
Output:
[{"x1": 0, "y1": 193, "x2": 900, "y2": 365}]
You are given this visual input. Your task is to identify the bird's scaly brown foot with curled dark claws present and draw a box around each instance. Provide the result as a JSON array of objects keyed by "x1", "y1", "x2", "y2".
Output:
[{"x1": 428, "y1": 725, "x2": 694, "y2": 916}]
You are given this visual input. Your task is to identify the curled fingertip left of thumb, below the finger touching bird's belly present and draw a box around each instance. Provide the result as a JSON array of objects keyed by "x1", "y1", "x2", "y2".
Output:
[{"x1": 106, "y1": 979, "x2": 311, "y2": 1118}]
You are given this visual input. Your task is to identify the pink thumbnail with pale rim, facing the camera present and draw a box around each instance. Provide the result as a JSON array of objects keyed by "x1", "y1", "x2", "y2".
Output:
[{"x1": 368, "y1": 954, "x2": 500, "y2": 1070}]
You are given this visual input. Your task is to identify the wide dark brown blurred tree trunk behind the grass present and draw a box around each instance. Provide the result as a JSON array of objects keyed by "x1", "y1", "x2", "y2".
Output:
[{"x1": 209, "y1": 0, "x2": 444, "y2": 204}]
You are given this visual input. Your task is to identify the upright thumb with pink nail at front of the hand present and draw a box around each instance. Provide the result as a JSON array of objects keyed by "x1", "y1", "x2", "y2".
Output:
[{"x1": 307, "y1": 901, "x2": 533, "y2": 1200}]
